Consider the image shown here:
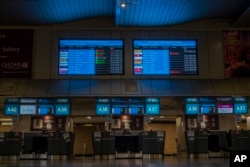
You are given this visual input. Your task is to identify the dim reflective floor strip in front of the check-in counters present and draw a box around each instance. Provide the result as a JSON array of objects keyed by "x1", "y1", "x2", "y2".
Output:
[{"x1": 0, "y1": 156, "x2": 230, "y2": 167}]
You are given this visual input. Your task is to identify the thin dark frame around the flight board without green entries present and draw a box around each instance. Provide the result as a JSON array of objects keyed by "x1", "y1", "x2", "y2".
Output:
[{"x1": 132, "y1": 39, "x2": 199, "y2": 76}]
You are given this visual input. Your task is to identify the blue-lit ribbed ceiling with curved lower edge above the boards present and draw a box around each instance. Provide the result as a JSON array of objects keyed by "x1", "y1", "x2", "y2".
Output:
[{"x1": 0, "y1": 0, "x2": 250, "y2": 28}]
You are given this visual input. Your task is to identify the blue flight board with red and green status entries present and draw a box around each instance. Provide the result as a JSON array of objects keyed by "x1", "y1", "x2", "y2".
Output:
[{"x1": 58, "y1": 39, "x2": 124, "y2": 75}]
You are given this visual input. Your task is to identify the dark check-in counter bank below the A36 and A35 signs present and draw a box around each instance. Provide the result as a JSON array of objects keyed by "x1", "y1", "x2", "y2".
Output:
[{"x1": 185, "y1": 130, "x2": 250, "y2": 157}]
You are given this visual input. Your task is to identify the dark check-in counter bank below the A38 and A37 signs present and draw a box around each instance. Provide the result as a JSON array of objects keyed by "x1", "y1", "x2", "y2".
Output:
[{"x1": 93, "y1": 131, "x2": 165, "y2": 159}]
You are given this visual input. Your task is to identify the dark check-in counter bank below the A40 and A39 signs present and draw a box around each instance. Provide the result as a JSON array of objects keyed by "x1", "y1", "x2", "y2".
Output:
[{"x1": 0, "y1": 131, "x2": 74, "y2": 159}]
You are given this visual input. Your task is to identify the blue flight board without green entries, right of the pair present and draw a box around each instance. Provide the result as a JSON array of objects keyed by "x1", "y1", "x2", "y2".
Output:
[{"x1": 133, "y1": 40, "x2": 198, "y2": 75}]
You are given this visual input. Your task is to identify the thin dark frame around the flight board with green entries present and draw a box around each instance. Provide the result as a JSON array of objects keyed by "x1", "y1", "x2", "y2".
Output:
[{"x1": 57, "y1": 38, "x2": 125, "y2": 77}]
